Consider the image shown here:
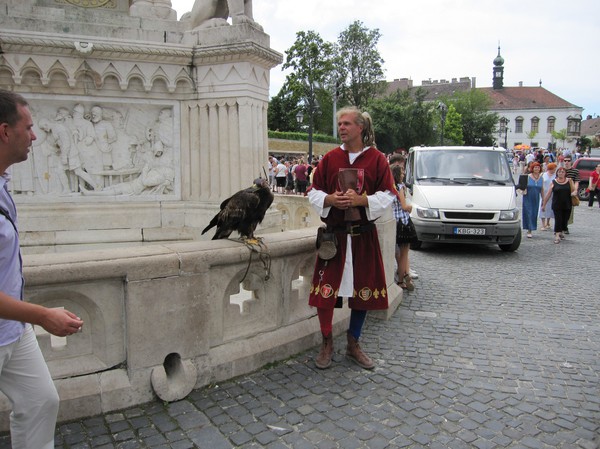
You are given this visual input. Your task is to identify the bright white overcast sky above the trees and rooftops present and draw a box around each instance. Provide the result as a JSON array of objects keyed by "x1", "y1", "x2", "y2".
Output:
[{"x1": 171, "y1": 0, "x2": 600, "y2": 119}]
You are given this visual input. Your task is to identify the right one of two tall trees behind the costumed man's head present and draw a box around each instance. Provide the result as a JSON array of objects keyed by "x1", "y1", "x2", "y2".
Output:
[{"x1": 334, "y1": 20, "x2": 385, "y2": 109}]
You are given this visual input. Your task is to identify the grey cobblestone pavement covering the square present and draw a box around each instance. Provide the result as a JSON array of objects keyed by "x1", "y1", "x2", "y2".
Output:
[{"x1": 0, "y1": 204, "x2": 600, "y2": 449}]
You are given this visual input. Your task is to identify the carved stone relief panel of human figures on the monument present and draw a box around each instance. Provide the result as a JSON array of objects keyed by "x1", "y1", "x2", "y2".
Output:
[{"x1": 11, "y1": 99, "x2": 179, "y2": 199}]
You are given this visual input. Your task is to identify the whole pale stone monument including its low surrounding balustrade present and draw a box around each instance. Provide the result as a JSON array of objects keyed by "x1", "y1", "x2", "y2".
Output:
[{"x1": 0, "y1": 0, "x2": 402, "y2": 430}]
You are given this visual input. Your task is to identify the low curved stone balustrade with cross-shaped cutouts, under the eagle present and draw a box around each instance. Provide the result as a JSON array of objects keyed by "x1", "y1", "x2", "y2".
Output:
[{"x1": 0, "y1": 210, "x2": 402, "y2": 430}]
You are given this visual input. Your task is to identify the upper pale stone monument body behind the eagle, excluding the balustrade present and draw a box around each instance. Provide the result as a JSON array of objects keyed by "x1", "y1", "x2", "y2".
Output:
[{"x1": 0, "y1": 0, "x2": 282, "y2": 251}]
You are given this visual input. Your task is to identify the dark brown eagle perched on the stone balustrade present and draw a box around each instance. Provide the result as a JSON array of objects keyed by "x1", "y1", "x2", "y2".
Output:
[{"x1": 202, "y1": 178, "x2": 273, "y2": 240}]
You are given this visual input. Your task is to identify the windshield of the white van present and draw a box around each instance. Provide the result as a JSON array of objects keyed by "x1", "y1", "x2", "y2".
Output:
[{"x1": 414, "y1": 148, "x2": 513, "y2": 183}]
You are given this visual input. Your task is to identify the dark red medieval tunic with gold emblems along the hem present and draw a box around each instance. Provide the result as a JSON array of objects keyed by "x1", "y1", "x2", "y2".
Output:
[{"x1": 309, "y1": 147, "x2": 395, "y2": 310}]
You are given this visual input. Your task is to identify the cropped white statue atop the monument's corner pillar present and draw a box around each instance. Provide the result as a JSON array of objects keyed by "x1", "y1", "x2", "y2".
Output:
[{"x1": 190, "y1": 0, "x2": 262, "y2": 29}]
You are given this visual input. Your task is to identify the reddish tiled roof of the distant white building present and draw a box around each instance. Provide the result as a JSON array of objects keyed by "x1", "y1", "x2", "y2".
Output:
[{"x1": 478, "y1": 86, "x2": 578, "y2": 110}]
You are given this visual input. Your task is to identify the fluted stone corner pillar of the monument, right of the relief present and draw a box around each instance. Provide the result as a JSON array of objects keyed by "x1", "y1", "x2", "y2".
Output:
[{"x1": 181, "y1": 24, "x2": 281, "y2": 202}]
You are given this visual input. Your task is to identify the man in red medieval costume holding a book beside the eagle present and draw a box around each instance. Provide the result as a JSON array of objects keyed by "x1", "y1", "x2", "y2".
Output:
[{"x1": 308, "y1": 107, "x2": 396, "y2": 369}]
